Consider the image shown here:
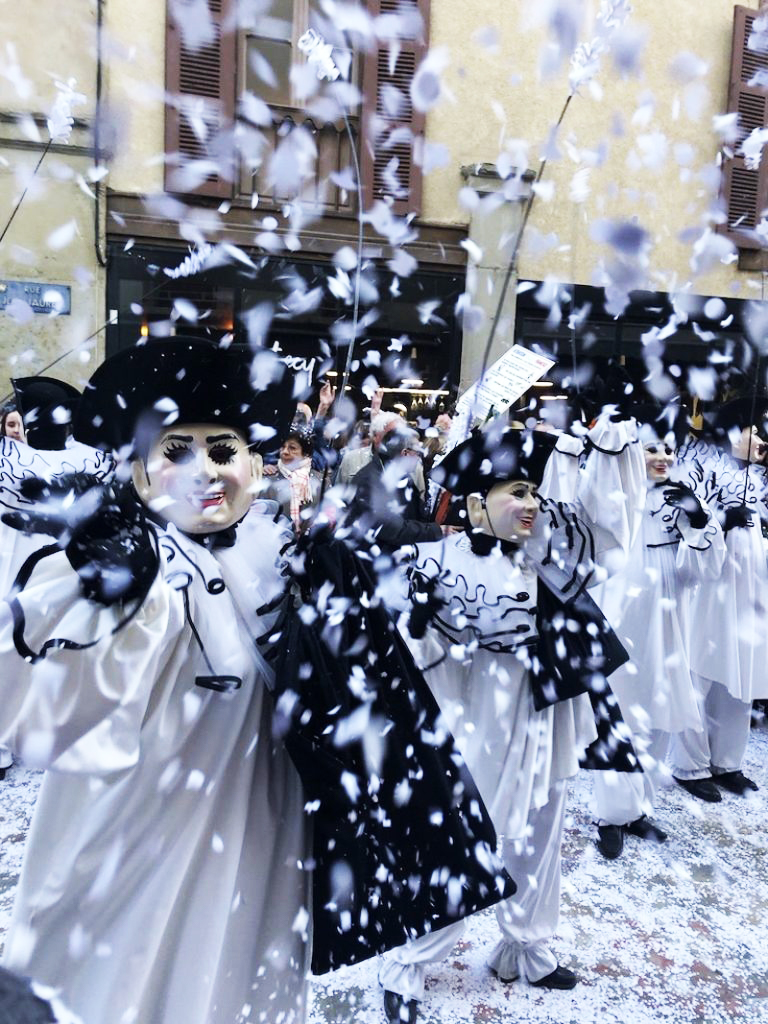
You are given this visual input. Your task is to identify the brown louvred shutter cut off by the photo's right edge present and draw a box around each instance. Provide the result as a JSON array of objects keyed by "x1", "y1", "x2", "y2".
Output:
[{"x1": 722, "y1": 6, "x2": 768, "y2": 249}]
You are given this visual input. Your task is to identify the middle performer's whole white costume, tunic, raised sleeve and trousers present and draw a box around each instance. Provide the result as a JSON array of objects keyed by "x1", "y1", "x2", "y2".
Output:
[{"x1": 379, "y1": 419, "x2": 645, "y2": 999}]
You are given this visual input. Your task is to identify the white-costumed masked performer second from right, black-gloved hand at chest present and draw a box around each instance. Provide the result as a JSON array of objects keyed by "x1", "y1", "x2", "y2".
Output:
[{"x1": 590, "y1": 407, "x2": 725, "y2": 860}]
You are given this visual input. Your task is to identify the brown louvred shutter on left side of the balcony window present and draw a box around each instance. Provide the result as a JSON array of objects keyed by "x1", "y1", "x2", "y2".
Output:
[{"x1": 165, "y1": 0, "x2": 238, "y2": 198}]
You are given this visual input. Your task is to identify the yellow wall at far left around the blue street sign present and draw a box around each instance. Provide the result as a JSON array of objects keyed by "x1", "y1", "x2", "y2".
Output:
[{"x1": 0, "y1": 0, "x2": 105, "y2": 398}]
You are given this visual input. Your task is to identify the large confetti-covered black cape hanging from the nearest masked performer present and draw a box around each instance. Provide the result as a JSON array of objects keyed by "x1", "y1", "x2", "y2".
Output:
[{"x1": 267, "y1": 536, "x2": 515, "y2": 974}]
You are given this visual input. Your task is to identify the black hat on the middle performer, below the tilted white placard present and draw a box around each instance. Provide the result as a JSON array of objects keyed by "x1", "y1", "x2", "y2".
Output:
[{"x1": 431, "y1": 427, "x2": 557, "y2": 496}]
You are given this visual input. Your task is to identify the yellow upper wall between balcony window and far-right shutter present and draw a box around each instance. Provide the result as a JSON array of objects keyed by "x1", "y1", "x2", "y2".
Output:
[{"x1": 423, "y1": 0, "x2": 759, "y2": 297}]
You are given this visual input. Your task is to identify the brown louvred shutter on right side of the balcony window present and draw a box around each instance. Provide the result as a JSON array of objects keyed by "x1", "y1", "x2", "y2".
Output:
[{"x1": 360, "y1": 0, "x2": 429, "y2": 215}]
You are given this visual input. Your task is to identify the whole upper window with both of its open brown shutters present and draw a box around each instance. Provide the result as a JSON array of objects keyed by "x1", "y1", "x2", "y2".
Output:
[{"x1": 166, "y1": 0, "x2": 429, "y2": 214}]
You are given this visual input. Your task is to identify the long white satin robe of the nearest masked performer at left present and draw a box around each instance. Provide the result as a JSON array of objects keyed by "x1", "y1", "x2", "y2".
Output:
[{"x1": 0, "y1": 513, "x2": 309, "y2": 1024}]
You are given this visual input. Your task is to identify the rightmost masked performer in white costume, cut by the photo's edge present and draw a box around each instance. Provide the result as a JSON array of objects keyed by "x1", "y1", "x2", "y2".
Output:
[{"x1": 671, "y1": 397, "x2": 768, "y2": 803}]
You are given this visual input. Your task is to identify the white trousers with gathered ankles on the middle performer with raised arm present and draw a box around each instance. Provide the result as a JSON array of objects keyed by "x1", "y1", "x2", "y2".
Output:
[{"x1": 379, "y1": 781, "x2": 566, "y2": 999}]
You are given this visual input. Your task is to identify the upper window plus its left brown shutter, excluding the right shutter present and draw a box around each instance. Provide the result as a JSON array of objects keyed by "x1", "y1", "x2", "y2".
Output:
[{"x1": 166, "y1": 0, "x2": 359, "y2": 213}]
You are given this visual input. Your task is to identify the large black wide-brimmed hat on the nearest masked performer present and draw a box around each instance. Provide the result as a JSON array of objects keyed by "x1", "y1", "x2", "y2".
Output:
[{"x1": 74, "y1": 338, "x2": 296, "y2": 455}]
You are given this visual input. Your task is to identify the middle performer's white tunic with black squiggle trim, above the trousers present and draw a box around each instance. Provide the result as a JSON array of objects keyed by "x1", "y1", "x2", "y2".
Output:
[{"x1": 410, "y1": 535, "x2": 597, "y2": 840}]
